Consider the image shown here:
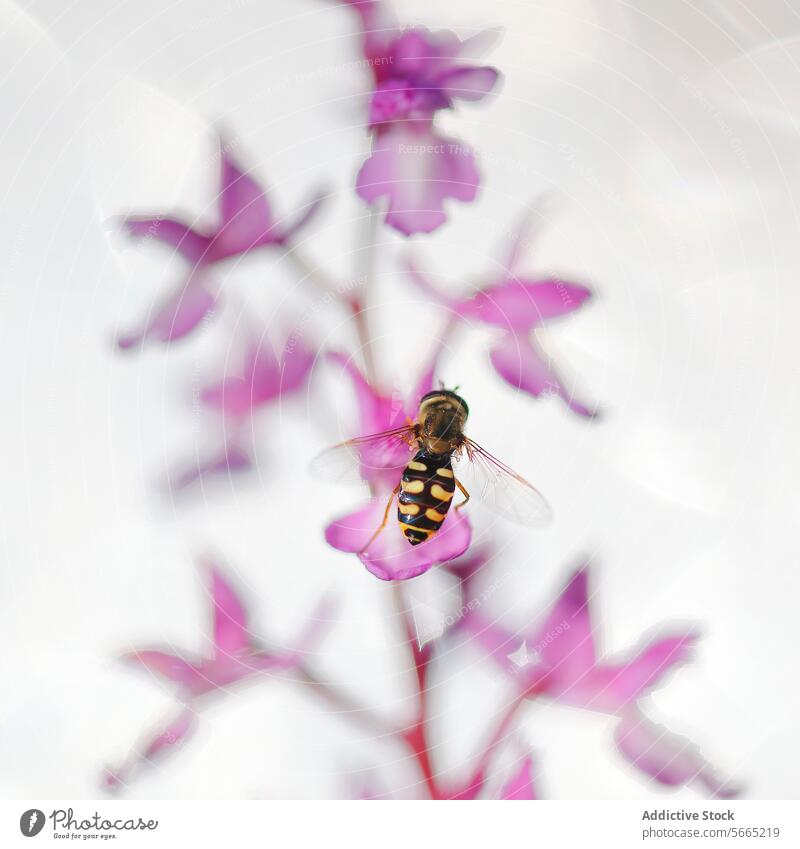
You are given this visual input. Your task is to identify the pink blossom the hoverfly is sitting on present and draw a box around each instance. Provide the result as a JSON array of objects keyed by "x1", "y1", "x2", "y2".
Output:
[{"x1": 325, "y1": 355, "x2": 472, "y2": 581}]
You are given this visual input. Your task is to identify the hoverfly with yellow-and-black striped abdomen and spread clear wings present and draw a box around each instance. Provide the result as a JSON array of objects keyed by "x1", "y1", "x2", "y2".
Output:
[{"x1": 312, "y1": 389, "x2": 550, "y2": 553}]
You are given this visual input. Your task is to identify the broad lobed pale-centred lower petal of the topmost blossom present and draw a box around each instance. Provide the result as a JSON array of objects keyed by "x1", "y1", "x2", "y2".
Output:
[{"x1": 356, "y1": 122, "x2": 479, "y2": 236}]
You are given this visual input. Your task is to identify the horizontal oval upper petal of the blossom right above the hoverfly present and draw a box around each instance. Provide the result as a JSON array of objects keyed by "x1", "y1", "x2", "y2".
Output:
[{"x1": 469, "y1": 278, "x2": 592, "y2": 331}]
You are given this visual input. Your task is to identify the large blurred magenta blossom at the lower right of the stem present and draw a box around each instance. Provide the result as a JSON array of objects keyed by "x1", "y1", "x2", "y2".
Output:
[{"x1": 459, "y1": 567, "x2": 736, "y2": 797}]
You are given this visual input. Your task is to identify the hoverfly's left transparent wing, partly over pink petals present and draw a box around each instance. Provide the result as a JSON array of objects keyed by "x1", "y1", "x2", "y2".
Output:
[{"x1": 311, "y1": 425, "x2": 417, "y2": 481}]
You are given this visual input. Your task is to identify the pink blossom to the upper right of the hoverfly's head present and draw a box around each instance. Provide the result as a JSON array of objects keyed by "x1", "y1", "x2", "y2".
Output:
[{"x1": 408, "y1": 206, "x2": 594, "y2": 416}]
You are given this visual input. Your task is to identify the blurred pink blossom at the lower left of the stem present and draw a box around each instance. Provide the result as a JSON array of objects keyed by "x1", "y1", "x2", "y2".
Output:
[{"x1": 103, "y1": 564, "x2": 329, "y2": 791}]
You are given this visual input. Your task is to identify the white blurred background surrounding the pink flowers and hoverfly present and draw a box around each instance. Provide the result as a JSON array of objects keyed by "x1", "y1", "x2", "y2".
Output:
[{"x1": 0, "y1": 0, "x2": 800, "y2": 798}]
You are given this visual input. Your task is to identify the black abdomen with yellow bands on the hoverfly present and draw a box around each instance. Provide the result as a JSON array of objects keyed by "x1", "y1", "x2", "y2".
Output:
[{"x1": 397, "y1": 451, "x2": 456, "y2": 545}]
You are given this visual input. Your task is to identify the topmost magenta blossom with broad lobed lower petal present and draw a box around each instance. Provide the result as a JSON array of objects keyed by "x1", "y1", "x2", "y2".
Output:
[{"x1": 336, "y1": 0, "x2": 499, "y2": 236}]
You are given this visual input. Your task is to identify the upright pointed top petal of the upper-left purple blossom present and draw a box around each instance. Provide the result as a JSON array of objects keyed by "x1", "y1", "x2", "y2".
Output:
[{"x1": 217, "y1": 140, "x2": 275, "y2": 254}]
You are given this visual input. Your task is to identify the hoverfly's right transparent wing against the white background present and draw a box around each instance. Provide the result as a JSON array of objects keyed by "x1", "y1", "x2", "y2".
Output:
[{"x1": 454, "y1": 439, "x2": 552, "y2": 525}]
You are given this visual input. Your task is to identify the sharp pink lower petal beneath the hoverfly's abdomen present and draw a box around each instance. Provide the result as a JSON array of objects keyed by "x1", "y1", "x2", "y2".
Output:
[{"x1": 325, "y1": 493, "x2": 472, "y2": 581}]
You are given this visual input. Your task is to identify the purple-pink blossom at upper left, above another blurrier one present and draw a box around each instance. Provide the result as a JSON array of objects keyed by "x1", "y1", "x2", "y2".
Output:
[{"x1": 117, "y1": 139, "x2": 322, "y2": 348}]
